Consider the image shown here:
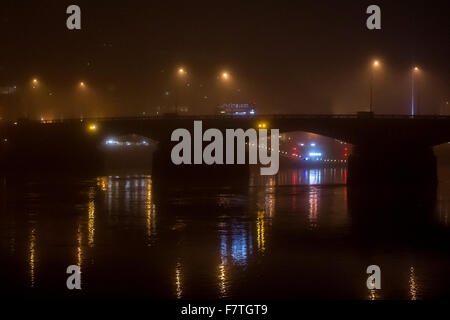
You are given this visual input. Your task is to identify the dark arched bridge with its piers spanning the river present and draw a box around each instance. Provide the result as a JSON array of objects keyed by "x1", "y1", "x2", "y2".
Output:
[{"x1": 0, "y1": 115, "x2": 450, "y2": 184}]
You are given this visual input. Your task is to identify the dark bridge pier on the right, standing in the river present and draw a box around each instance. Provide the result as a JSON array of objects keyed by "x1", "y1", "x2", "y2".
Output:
[{"x1": 347, "y1": 145, "x2": 437, "y2": 185}]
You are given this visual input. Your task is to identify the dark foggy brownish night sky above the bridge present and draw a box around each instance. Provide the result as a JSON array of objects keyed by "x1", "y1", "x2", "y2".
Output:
[{"x1": 0, "y1": 0, "x2": 450, "y2": 116}]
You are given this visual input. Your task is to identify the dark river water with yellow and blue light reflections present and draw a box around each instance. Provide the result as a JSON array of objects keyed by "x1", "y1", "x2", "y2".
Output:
[{"x1": 0, "y1": 160, "x2": 450, "y2": 300}]
